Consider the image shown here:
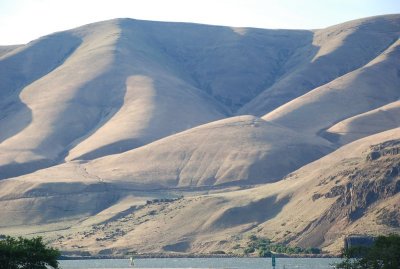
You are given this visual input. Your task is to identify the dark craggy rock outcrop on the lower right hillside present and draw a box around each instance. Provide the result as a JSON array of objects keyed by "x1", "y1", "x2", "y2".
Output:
[{"x1": 298, "y1": 140, "x2": 400, "y2": 246}]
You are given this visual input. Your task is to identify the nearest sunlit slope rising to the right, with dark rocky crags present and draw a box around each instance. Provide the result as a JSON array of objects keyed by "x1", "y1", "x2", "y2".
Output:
[{"x1": 91, "y1": 128, "x2": 400, "y2": 253}]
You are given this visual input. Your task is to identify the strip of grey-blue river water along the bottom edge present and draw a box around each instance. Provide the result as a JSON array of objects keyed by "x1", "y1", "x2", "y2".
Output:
[{"x1": 60, "y1": 258, "x2": 339, "y2": 269}]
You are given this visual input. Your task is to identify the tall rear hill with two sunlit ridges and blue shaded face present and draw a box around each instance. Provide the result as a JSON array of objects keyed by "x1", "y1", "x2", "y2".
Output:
[{"x1": 0, "y1": 19, "x2": 310, "y2": 178}]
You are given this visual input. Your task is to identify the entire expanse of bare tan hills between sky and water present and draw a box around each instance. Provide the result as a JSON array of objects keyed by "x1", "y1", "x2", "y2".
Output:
[{"x1": 0, "y1": 14, "x2": 400, "y2": 255}]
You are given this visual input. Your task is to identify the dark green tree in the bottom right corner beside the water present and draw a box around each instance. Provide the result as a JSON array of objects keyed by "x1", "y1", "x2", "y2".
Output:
[{"x1": 336, "y1": 234, "x2": 400, "y2": 269}]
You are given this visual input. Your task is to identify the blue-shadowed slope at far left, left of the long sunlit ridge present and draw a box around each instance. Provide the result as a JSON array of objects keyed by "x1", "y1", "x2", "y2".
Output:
[{"x1": 0, "y1": 33, "x2": 80, "y2": 147}]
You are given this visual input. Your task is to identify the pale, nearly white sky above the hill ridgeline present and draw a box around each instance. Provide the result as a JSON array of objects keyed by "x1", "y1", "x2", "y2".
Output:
[{"x1": 0, "y1": 0, "x2": 400, "y2": 45}]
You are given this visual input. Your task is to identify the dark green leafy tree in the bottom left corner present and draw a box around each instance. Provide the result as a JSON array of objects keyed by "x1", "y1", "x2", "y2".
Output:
[{"x1": 0, "y1": 236, "x2": 60, "y2": 269}]
